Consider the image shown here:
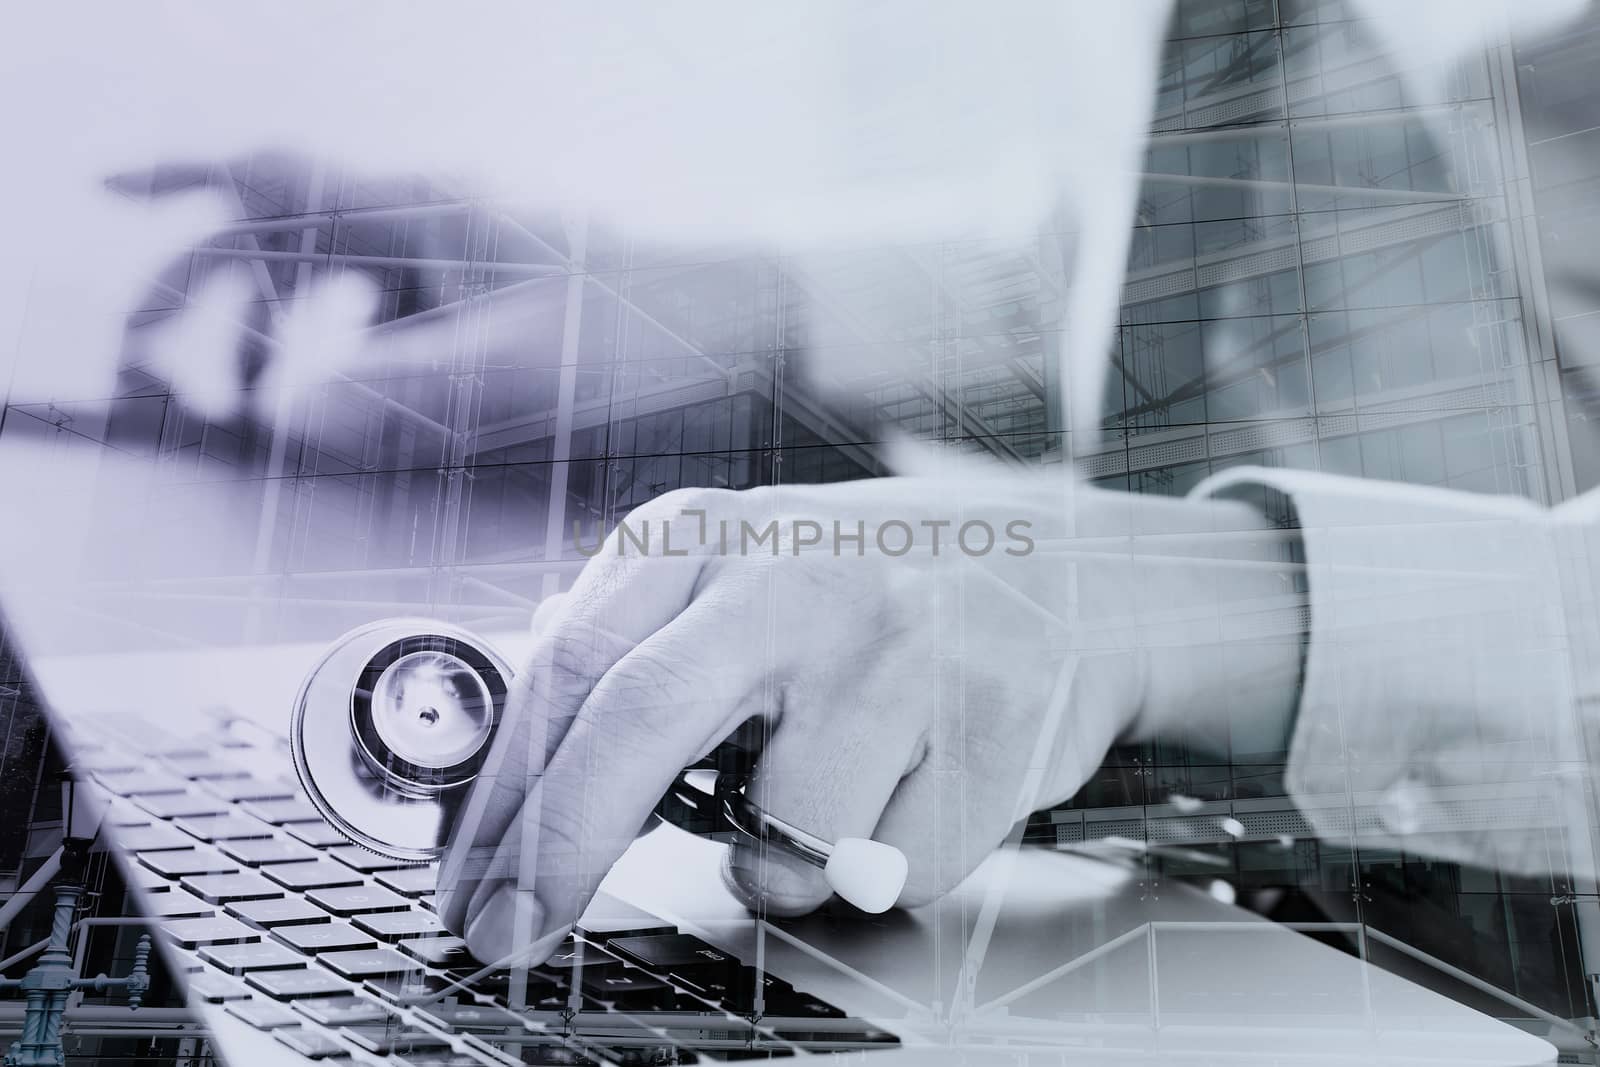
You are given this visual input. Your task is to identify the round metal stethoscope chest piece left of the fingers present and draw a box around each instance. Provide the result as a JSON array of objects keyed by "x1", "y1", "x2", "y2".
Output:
[{"x1": 290, "y1": 619, "x2": 512, "y2": 861}]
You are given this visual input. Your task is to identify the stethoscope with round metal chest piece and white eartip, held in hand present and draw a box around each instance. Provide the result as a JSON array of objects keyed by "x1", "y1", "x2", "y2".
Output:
[{"x1": 290, "y1": 619, "x2": 907, "y2": 912}]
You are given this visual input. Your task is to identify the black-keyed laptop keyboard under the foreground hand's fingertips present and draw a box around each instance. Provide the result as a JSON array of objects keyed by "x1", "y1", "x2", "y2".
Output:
[{"x1": 72, "y1": 715, "x2": 899, "y2": 1067}]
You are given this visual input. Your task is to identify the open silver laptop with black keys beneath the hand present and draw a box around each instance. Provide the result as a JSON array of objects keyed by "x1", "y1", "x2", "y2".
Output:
[{"x1": 0, "y1": 559, "x2": 1554, "y2": 1067}]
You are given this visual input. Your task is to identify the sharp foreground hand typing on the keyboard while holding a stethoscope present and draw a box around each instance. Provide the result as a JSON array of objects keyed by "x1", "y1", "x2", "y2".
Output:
[{"x1": 440, "y1": 475, "x2": 1299, "y2": 961}]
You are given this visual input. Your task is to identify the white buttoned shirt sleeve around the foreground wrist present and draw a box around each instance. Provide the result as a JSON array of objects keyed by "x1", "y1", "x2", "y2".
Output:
[{"x1": 1195, "y1": 469, "x2": 1600, "y2": 873}]
